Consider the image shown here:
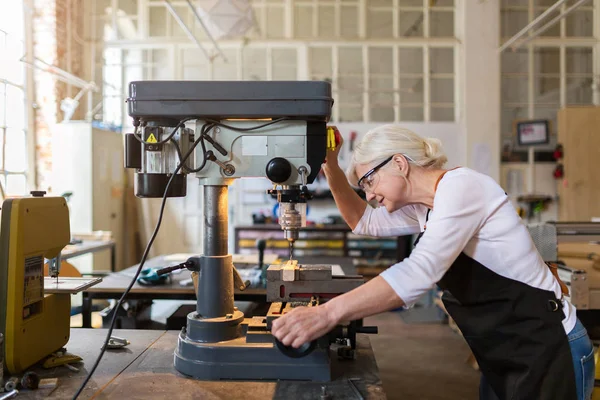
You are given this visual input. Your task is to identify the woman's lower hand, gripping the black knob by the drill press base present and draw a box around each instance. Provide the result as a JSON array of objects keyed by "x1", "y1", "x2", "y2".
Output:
[{"x1": 271, "y1": 306, "x2": 338, "y2": 348}]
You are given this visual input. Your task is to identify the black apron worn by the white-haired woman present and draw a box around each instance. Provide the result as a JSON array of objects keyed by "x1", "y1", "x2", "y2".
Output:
[{"x1": 415, "y1": 210, "x2": 577, "y2": 400}]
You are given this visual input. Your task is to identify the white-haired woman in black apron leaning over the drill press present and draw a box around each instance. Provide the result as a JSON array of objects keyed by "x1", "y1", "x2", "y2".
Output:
[{"x1": 272, "y1": 125, "x2": 594, "y2": 400}]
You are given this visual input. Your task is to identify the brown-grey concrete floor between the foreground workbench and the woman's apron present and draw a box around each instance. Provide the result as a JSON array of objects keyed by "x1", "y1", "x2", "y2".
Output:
[{"x1": 365, "y1": 312, "x2": 479, "y2": 400}]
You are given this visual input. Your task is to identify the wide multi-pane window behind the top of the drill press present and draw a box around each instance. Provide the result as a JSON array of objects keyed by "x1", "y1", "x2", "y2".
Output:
[{"x1": 94, "y1": 0, "x2": 458, "y2": 126}]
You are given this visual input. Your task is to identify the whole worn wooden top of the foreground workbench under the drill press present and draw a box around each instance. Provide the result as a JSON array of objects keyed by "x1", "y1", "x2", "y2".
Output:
[{"x1": 18, "y1": 329, "x2": 386, "y2": 400}]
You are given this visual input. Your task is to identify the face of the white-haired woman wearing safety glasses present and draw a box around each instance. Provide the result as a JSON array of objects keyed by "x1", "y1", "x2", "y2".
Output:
[{"x1": 356, "y1": 157, "x2": 408, "y2": 213}]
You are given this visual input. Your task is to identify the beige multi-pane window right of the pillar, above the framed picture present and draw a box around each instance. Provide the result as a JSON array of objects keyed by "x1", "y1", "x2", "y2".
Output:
[{"x1": 501, "y1": 0, "x2": 595, "y2": 143}]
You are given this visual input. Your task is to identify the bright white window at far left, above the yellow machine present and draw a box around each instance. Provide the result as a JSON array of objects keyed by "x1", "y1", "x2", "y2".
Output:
[{"x1": 0, "y1": 1, "x2": 28, "y2": 196}]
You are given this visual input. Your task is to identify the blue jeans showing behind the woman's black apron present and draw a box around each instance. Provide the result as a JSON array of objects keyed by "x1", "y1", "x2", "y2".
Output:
[{"x1": 568, "y1": 319, "x2": 596, "y2": 400}]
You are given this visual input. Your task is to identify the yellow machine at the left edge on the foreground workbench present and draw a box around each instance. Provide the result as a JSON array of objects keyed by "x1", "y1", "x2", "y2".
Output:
[{"x1": 0, "y1": 195, "x2": 71, "y2": 374}]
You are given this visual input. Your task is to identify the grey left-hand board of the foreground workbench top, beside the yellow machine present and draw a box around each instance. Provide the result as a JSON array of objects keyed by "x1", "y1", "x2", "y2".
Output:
[{"x1": 18, "y1": 329, "x2": 165, "y2": 400}]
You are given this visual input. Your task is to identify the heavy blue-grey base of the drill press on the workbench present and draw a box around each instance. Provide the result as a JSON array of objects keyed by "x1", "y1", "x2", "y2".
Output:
[{"x1": 175, "y1": 313, "x2": 331, "y2": 381}]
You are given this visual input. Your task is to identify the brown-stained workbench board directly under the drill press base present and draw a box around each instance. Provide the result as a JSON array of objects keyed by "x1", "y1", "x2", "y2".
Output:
[{"x1": 98, "y1": 331, "x2": 386, "y2": 400}]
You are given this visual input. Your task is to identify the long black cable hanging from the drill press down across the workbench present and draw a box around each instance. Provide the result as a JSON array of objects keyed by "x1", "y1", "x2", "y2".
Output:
[{"x1": 73, "y1": 123, "x2": 202, "y2": 400}]
